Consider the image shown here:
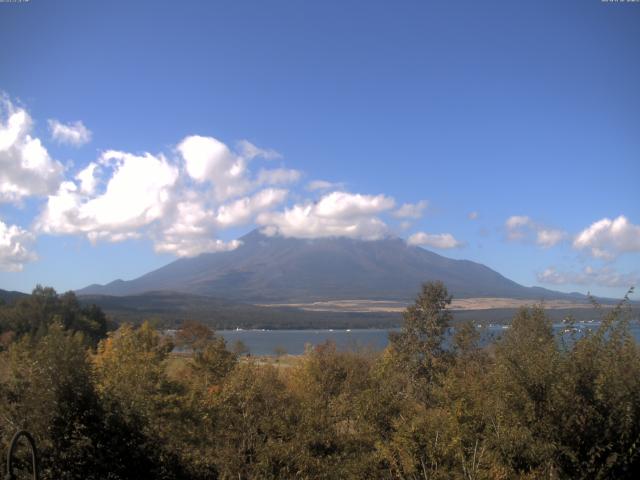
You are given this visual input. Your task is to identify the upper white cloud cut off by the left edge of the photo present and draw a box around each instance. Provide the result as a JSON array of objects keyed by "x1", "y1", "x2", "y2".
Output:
[{"x1": 0, "y1": 96, "x2": 64, "y2": 203}]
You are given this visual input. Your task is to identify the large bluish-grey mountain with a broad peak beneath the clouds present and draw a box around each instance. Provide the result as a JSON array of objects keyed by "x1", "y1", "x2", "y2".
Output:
[{"x1": 77, "y1": 230, "x2": 584, "y2": 303}]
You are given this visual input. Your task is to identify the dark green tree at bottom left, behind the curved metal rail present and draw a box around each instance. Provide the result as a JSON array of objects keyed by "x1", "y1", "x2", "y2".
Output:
[{"x1": 0, "y1": 323, "x2": 131, "y2": 480}]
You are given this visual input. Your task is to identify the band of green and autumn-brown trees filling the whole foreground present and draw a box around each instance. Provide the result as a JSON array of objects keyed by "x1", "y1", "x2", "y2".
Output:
[{"x1": 0, "y1": 282, "x2": 640, "y2": 480}]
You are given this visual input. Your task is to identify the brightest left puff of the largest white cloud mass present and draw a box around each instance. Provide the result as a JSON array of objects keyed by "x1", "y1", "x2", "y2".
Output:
[{"x1": 37, "y1": 150, "x2": 178, "y2": 242}]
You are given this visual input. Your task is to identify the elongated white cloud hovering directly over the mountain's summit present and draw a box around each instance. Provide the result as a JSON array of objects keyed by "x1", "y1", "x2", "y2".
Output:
[{"x1": 257, "y1": 192, "x2": 395, "y2": 240}]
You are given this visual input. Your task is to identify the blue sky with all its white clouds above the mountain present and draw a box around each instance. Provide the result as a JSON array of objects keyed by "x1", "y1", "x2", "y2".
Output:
[{"x1": 0, "y1": 0, "x2": 640, "y2": 297}]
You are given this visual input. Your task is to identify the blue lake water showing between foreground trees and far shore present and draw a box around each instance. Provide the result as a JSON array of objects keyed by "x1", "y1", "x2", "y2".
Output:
[{"x1": 217, "y1": 322, "x2": 640, "y2": 355}]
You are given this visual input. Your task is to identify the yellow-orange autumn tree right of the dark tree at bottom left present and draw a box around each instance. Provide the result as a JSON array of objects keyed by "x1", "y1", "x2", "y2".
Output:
[{"x1": 93, "y1": 322, "x2": 185, "y2": 479}]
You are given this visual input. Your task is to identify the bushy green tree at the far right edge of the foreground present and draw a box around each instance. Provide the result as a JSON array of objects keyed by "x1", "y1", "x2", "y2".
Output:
[{"x1": 554, "y1": 295, "x2": 640, "y2": 479}]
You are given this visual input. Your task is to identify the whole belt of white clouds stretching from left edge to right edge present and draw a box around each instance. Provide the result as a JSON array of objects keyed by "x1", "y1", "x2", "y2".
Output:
[{"x1": 0, "y1": 92, "x2": 640, "y2": 298}]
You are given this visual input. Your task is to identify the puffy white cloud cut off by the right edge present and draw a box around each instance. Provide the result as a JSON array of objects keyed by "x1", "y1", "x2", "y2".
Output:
[{"x1": 573, "y1": 215, "x2": 640, "y2": 260}]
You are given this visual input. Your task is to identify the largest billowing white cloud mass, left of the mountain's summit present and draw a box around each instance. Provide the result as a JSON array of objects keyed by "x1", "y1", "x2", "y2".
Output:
[{"x1": 36, "y1": 136, "x2": 300, "y2": 256}]
